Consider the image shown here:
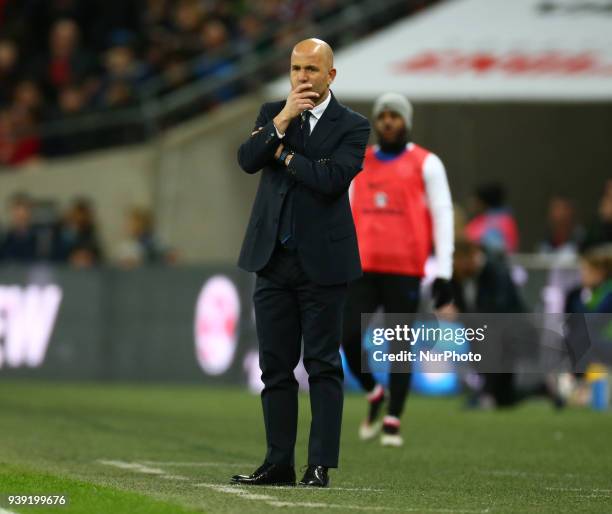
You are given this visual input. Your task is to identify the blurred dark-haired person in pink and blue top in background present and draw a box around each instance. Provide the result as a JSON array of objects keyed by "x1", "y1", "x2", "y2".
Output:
[{"x1": 465, "y1": 183, "x2": 519, "y2": 252}]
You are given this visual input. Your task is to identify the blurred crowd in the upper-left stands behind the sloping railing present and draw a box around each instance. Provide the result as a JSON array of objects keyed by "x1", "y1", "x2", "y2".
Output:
[{"x1": 0, "y1": 0, "x2": 433, "y2": 168}]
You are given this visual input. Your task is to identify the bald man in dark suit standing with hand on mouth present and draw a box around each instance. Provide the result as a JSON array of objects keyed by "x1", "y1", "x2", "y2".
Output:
[{"x1": 232, "y1": 39, "x2": 370, "y2": 487}]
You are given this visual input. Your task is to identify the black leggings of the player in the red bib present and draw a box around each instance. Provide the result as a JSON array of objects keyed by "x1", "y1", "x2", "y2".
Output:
[{"x1": 342, "y1": 273, "x2": 421, "y2": 418}]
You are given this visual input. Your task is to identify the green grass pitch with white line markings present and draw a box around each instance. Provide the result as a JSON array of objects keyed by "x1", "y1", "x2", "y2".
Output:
[{"x1": 0, "y1": 381, "x2": 612, "y2": 514}]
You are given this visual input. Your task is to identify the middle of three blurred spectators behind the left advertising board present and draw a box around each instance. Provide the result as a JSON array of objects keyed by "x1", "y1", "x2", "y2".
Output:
[{"x1": 54, "y1": 198, "x2": 102, "y2": 268}]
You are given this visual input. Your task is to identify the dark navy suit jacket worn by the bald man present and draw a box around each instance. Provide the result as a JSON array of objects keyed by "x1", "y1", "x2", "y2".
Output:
[{"x1": 238, "y1": 93, "x2": 370, "y2": 285}]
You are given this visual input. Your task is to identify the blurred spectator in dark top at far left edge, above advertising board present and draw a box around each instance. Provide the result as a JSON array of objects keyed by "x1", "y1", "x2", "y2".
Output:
[{"x1": 0, "y1": 193, "x2": 38, "y2": 264}]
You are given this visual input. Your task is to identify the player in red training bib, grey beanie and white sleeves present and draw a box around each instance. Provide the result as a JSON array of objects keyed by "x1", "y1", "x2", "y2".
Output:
[{"x1": 342, "y1": 93, "x2": 455, "y2": 446}]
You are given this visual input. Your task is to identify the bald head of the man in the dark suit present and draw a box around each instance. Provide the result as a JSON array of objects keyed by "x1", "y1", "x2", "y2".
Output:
[{"x1": 291, "y1": 38, "x2": 336, "y2": 103}]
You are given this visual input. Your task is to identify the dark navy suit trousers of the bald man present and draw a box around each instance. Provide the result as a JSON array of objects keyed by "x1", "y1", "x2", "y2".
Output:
[{"x1": 253, "y1": 246, "x2": 347, "y2": 468}]
